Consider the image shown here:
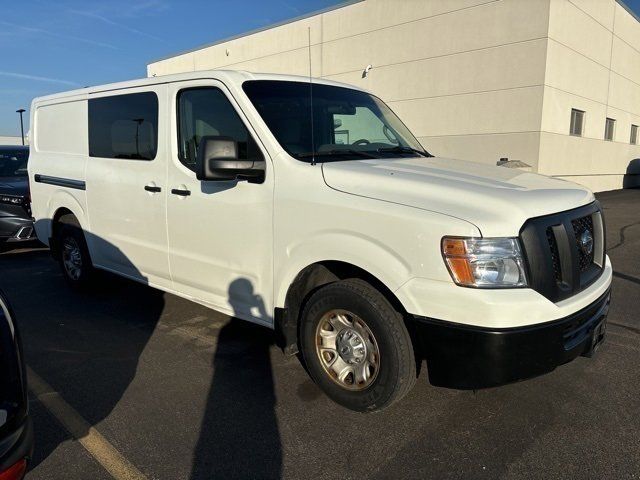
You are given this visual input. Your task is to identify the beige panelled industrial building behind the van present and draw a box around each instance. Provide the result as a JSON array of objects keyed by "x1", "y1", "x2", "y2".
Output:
[{"x1": 147, "y1": 0, "x2": 640, "y2": 191}]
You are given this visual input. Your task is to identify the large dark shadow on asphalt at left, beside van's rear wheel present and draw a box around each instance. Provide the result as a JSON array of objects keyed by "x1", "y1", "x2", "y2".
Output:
[{"x1": 0, "y1": 242, "x2": 164, "y2": 469}]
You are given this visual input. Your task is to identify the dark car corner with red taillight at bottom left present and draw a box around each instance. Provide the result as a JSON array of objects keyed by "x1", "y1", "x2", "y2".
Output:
[{"x1": 0, "y1": 291, "x2": 33, "y2": 480}]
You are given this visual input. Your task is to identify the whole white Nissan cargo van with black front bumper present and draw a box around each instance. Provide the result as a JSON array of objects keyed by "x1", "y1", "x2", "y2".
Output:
[{"x1": 29, "y1": 71, "x2": 612, "y2": 411}]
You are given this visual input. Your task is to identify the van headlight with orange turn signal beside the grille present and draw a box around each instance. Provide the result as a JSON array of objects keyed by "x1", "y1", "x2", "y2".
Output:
[{"x1": 442, "y1": 237, "x2": 527, "y2": 288}]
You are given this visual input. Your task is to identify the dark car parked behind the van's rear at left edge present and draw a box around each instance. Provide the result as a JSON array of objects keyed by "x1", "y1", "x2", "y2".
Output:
[{"x1": 0, "y1": 146, "x2": 35, "y2": 248}]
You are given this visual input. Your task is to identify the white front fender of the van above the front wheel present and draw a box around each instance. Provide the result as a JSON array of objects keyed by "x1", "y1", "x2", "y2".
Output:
[{"x1": 274, "y1": 153, "x2": 480, "y2": 312}]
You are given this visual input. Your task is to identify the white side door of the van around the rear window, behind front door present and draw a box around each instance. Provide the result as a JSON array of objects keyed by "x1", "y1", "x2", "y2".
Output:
[{"x1": 85, "y1": 85, "x2": 172, "y2": 288}]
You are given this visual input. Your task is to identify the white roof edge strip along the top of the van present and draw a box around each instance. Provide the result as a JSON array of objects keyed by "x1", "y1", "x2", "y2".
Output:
[{"x1": 33, "y1": 70, "x2": 362, "y2": 103}]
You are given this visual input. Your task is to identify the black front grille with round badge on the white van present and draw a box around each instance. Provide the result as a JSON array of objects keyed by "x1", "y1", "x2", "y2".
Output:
[{"x1": 520, "y1": 201, "x2": 605, "y2": 302}]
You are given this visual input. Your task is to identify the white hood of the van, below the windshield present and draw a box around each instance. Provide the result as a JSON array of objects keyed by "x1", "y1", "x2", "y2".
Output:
[{"x1": 322, "y1": 157, "x2": 595, "y2": 237}]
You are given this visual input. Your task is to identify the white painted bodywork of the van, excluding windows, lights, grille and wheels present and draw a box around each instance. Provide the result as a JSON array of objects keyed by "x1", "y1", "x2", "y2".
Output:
[{"x1": 29, "y1": 71, "x2": 611, "y2": 327}]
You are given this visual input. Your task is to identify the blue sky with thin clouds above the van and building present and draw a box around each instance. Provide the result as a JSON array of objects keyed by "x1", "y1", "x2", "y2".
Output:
[{"x1": 0, "y1": 0, "x2": 640, "y2": 135}]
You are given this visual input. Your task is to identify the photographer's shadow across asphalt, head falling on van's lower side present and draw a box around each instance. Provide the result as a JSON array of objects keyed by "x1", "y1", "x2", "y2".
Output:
[{"x1": 191, "y1": 278, "x2": 282, "y2": 480}]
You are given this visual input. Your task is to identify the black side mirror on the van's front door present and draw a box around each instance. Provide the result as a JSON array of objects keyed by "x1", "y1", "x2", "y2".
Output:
[{"x1": 196, "y1": 136, "x2": 265, "y2": 183}]
